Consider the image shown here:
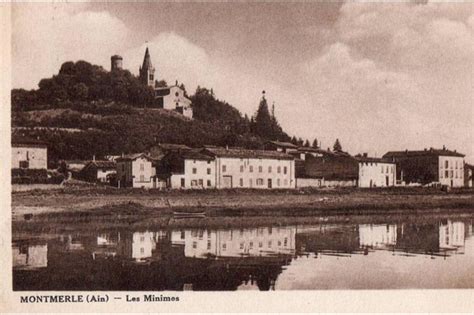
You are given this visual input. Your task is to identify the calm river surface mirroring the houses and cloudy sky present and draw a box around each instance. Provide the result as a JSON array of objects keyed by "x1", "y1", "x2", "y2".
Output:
[{"x1": 13, "y1": 220, "x2": 474, "y2": 290}]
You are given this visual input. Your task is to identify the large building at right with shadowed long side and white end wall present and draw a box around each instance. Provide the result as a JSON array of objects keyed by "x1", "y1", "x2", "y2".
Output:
[{"x1": 383, "y1": 147, "x2": 464, "y2": 187}]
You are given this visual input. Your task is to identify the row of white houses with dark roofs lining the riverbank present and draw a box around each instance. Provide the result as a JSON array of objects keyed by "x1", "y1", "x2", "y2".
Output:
[{"x1": 12, "y1": 138, "x2": 474, "y2": 189}]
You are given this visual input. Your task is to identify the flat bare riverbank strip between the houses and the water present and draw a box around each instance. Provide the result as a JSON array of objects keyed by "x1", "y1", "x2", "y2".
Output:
[{"x1": 12, "y1": 187, "x2": 474, "y2": 220}]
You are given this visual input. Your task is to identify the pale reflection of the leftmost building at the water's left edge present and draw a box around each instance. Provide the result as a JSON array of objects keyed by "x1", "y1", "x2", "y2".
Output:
[{"x1": 12, "y1": 245, "x2": 48, "y2": 269}]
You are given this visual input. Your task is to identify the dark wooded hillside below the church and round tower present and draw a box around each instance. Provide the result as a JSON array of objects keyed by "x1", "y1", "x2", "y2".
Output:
[{"x1": 12, "y1": 61, "x2": 290, "y2": 167}]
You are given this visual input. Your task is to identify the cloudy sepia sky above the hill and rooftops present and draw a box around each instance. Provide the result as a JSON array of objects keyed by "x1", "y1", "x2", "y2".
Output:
[{"x1": 12, "y1": 1, "x2": 474, "y2": 162}]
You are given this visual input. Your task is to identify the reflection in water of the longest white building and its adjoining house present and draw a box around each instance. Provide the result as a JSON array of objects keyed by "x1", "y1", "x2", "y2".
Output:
[{"x1": 171, "y1": 227, "x2": 296, "y2": 258}]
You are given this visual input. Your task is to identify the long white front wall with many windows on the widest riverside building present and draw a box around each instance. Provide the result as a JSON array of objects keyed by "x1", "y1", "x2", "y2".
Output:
[{"x1": 216, "y1": 157, "x2": 296, "y2": 189}]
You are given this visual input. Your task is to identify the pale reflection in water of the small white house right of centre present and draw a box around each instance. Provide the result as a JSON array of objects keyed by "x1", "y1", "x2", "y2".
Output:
[{"x1": 359, "y1": 224, "x2": 397, "y2": 249}]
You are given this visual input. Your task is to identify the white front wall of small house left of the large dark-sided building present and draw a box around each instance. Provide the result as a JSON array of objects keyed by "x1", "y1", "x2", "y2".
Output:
[{"x1": 358, "y1": 162, "x2": 396, "y2": 187}]
